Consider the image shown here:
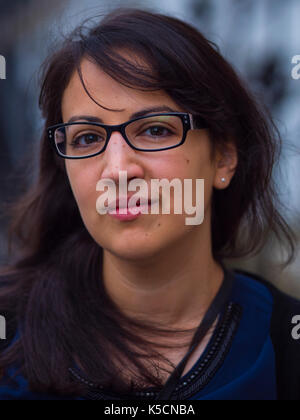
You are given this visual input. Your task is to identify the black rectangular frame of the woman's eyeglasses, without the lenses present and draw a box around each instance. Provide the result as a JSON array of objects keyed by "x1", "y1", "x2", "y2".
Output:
[{"x1": 47, "y1": 112, "x2": 207, "y2": 160}]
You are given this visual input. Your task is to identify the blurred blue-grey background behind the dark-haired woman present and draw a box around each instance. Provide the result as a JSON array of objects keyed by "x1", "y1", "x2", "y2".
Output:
[{"x1": 0, "y1": 0, "x2": 300, "y2": 297}]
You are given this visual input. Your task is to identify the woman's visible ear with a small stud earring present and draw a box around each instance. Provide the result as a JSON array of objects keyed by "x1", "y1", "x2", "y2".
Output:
[{"x1": 214, "y1": 141, "x2": 238, "y2": 190}]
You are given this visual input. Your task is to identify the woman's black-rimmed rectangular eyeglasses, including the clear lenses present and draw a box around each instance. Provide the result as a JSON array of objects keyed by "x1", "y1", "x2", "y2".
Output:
[{"x1": 47, "y1": 112, "x2": 207, "y2": 159}]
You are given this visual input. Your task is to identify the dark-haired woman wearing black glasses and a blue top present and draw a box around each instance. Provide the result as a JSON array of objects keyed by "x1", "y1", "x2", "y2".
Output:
[{"x1": 0, "y1": 9, "x2": 300, "y2": 400}]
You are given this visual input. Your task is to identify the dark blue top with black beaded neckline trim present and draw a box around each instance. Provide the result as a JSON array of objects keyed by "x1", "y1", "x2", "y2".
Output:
[{"x1": 0, "y1": 273, "x2": 277, "y2": 400}]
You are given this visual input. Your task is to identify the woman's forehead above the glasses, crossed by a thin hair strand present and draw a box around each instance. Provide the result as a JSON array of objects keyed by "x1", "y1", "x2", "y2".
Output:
[{"x1": 62, "y1": 59, "x2": 182, "y2": 121}]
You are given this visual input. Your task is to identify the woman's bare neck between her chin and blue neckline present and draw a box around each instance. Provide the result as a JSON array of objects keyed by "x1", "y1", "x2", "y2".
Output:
[{"x1": 103, "y1": 228, "x2": 224, "y2": 328}]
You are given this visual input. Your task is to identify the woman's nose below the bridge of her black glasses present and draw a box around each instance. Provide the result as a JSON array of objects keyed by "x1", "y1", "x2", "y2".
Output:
[{"x1": 101, "y1": 132, "x2": 145, "y2": 184}]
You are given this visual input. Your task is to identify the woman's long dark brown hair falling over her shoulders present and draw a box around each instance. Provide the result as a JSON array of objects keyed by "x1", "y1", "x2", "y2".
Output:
[{"x1": 0, "y1": 5, "x2": 295, "y2": 394}]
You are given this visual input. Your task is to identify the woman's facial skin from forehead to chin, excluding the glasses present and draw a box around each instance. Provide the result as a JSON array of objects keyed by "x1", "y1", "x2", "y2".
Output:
[{"x1": 62, "y1": 60, "x2": 230, "y2": 259}]
